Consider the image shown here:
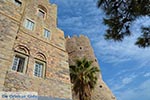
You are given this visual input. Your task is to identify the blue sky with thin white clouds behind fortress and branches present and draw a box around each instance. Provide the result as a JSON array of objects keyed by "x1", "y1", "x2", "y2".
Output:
[{"x1": 51, "y1": 0, "x2": 150, "y2": 100}]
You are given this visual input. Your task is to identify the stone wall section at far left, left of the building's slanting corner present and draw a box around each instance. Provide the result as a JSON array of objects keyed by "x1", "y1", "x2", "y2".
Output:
[{"x1": 0, "y1": 0, "x2": 20, "y2": 91}]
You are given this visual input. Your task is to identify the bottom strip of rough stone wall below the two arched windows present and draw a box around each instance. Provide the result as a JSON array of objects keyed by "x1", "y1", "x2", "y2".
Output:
[{"x1": 4, "y1": 71, "x2": 71, "y2": 99}]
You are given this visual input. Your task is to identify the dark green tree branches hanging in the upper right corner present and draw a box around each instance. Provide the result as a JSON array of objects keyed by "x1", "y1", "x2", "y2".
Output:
[{"x1": 98, "y1": 0, "x2": 150, "y2": 47}]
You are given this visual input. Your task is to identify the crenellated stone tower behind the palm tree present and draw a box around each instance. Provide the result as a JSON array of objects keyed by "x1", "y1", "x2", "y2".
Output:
[{"x1": 66, "y1": 35, "x2": 116, "y2": 100}]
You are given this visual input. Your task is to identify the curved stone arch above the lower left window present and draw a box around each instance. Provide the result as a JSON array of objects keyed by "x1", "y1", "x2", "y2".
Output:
[{"x1": 14, "y1": 45, "x2": 30, "y2": 55}]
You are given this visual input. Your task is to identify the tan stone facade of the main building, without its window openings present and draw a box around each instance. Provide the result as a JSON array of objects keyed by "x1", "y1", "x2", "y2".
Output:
[{"x1": 0, "y1": 0, "x2": 72, "y2": 100}]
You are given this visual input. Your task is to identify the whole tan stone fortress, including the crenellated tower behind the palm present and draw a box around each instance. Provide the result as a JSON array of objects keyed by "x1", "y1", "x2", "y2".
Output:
[{"x1": 0, "y1": 0, "x2": 114, "y2": 100}]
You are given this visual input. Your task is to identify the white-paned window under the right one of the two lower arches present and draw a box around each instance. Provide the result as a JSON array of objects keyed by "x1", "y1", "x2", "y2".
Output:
[{"x1": 34, "y1": 62, "x2": 44, "y2": 77}]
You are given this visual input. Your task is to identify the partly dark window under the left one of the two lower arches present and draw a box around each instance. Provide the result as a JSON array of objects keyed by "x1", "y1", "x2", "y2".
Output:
[{"x1": 12, "y1": 55, "x2": 25, "y2": 73}]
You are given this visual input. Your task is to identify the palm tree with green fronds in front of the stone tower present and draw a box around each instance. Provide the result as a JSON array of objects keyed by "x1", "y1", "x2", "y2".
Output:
[{"x1": 70, "y1": 58, "x2": 99, "y2": 100}]
